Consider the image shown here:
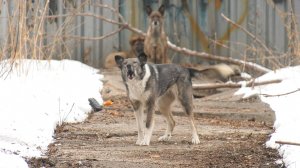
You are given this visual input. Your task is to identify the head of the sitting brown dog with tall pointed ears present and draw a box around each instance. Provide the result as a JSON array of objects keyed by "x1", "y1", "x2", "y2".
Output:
[{"x1": 146, "y1": 4, "x2": 165, "y2": 29}]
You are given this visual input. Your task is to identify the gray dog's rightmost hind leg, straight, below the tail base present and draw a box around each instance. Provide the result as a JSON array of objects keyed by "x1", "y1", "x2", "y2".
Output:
[{"x1": 178, "y1": 82, "x2": 200, "y2": 144}]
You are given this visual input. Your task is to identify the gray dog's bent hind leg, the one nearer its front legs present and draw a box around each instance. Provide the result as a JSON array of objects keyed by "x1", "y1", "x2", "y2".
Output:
[{"x1": 158, "y1": 91, "x2": 175, "y2": 141}]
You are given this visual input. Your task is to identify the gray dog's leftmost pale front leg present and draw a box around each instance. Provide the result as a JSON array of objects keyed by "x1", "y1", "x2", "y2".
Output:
[{"x1": 131, "y1": 100, "x2": 144, "y2": 145}]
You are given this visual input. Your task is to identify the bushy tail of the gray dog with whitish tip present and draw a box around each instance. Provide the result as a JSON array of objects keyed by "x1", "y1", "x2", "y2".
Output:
[{"x1": 187, "y1": 64, "x2": 241, "y2": 82}]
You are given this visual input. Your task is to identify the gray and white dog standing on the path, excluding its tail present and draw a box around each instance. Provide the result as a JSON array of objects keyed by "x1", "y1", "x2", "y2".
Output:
[{"x1": 115, "y1": 53, "x2": 200, "y2": 145}]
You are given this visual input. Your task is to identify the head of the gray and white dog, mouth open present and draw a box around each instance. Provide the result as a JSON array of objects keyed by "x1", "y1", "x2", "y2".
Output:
[{"x1": 115, "y1": 53, "x2": 147, "y2": 81}]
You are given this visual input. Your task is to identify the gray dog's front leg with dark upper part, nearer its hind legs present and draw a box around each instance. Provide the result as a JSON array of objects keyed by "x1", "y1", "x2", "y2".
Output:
[{"x1": 140, "y1": 97, "x2": 155, "y2": 145}]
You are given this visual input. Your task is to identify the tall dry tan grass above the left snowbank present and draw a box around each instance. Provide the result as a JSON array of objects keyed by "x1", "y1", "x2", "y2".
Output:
[{"x1": 0, "y1": 0, "x2": 81, "y2": 63}]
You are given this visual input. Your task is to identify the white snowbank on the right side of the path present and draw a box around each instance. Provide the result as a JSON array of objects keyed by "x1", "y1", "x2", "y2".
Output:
[{"x1": 237, "y1": 66, "x2": 300, "y2": 168}]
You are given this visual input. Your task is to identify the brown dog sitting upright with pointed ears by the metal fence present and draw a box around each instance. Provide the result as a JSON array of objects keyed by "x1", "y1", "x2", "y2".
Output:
[{"x1": 144, "y1": 5, "x2": 169, "y2": 64}]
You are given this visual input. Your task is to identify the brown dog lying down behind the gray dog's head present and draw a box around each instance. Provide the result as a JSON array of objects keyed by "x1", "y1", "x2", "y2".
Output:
[{"x1": 104, "y1": 36, "x2": 145, "y2": 68}]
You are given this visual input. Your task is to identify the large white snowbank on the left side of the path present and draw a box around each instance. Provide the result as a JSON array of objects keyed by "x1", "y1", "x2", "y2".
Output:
[{"x1": 0, "y1": 60, "x2": 102, "y2": 167}]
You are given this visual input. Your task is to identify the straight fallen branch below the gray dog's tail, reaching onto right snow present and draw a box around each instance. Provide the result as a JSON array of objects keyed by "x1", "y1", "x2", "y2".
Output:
[{"x1": 193, "y1": 79, "x2": 282, "y2": 90}]
